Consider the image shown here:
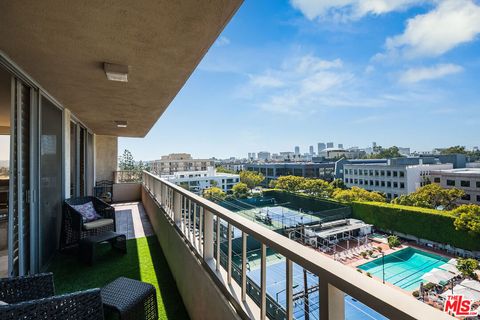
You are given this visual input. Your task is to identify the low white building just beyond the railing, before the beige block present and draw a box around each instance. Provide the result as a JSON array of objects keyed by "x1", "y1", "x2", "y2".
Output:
[{"x1": 161, "y1": 167, "x2": 240, "y2": 194}]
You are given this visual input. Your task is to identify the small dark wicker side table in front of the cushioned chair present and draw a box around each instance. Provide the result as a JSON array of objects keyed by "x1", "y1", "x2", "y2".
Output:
[{"x1": 80, "y1": 231, "x2": 127, "y2": 265}]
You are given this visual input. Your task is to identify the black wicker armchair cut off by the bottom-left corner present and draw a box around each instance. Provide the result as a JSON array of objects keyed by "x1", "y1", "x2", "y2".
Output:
[{"x1": 0, "y1": 273, "x2": 103, "y2": 320}]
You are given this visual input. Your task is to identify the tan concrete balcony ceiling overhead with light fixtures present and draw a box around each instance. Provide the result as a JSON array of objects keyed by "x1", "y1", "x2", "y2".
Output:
[{"x1": 0, "y1": 0, "x2": 242, "y2": 137}]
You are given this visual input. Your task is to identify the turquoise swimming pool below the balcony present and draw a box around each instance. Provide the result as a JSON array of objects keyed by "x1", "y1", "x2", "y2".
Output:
[{"x1": 358, "y1": 247, "x2": 449, "y2": 291}]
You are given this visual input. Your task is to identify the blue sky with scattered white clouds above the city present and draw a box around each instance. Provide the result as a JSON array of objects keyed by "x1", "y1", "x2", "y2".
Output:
[{"x1": 119, "y1": 0, "x2": 480, "y2": 160}]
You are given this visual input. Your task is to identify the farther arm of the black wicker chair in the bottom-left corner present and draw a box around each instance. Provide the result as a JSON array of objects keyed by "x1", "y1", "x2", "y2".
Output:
[{"x1": 0, "y1": 273, "x2": 55, "y2": 304}]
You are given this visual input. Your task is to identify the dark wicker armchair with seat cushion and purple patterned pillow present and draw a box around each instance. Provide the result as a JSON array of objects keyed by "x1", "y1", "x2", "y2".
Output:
[{"x1": 60, "y1": 197, "x2": 116, "y2": 249}]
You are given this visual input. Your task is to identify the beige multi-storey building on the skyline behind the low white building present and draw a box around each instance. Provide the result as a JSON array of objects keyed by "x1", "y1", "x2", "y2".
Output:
[{"x1": 149, "y1": 153, "x2": 215, "y2": 176}]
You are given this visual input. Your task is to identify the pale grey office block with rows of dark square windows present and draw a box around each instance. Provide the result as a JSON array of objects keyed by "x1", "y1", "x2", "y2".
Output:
[{"x1": 343, "y1": 158, "x2": 453, "y2": 199}]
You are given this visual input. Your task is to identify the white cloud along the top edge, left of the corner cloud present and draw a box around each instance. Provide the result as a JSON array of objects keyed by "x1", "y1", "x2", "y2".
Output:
[{"x1": 290, "y1": 0, "x2": 432, "y2": 20}]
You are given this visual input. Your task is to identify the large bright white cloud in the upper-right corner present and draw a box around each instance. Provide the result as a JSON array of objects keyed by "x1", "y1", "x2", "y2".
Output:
[{"x1": 384, "y1": 0, "x2": 480, "y2": 58}]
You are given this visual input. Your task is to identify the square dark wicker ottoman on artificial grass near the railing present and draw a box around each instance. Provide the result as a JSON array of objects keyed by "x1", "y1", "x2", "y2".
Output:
[{"x1": 101, "y1": 277, "x2": 158, "y2": 320}]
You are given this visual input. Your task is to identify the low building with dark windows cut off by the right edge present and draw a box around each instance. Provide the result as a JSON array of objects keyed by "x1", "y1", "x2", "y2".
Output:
[{"x1": 430, "y1": 168, "x2": 480, "y2": 204}]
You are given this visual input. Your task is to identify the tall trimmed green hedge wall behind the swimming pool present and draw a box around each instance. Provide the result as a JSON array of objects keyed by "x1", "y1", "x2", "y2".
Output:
[{"x1": 351, "y1": 202, "x2": 480, "y2": 251}]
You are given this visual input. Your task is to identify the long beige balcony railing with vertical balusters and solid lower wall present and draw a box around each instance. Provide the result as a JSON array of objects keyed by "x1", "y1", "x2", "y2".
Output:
[{"x1": 86, "y1": 172, "x2": 450, "y2": 319}]
